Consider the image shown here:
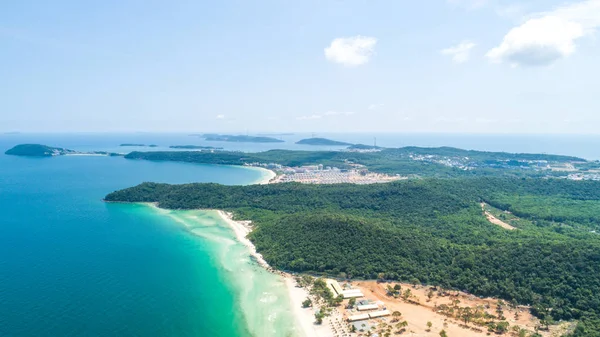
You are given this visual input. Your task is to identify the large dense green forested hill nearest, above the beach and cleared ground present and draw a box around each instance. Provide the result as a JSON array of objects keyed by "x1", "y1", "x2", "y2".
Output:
[{"x1": 106, "y1": 178, "x2": 600, "y2": 336}]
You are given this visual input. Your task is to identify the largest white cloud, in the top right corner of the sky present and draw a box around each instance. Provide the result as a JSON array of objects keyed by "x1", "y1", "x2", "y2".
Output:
[{"x1": 486, "y1": 0, "x2": 600, "y2": 66}]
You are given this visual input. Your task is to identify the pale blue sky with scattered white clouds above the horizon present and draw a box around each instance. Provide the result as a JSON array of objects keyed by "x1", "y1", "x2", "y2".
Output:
[{"x1": 0, "y1": 0, "x2": 600, "y2": 134}]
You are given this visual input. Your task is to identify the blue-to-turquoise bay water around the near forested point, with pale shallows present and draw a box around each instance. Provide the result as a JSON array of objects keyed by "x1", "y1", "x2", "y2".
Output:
[{"x1": 0, "y1": 141, "x2": 294, "y2": 337}]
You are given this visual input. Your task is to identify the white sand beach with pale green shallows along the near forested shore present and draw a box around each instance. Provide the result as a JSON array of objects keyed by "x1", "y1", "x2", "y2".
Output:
[{"x1": 144, "y1": 203, "x2": 310, "y2": 337}]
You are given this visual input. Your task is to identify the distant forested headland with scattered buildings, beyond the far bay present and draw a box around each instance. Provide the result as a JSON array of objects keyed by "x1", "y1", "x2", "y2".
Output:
[{"x1": 126, "y1": 146, "x2": 585, "y2": 178}]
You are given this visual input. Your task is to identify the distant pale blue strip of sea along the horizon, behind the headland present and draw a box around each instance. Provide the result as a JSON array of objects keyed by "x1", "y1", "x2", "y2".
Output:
[{"x1": 0, "y1": 133, "x2": 600, "y2": 160}]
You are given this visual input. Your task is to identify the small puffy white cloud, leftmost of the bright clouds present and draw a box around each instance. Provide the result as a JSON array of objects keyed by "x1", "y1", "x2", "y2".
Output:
[{"x1": 325, "y1": 35, "x2": 377, "y2": 67}]
